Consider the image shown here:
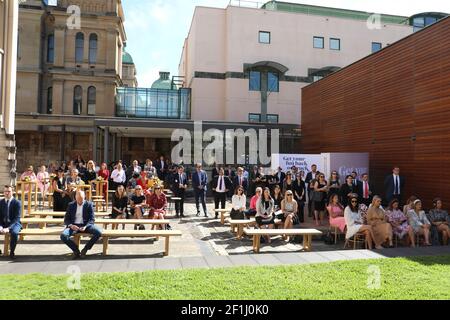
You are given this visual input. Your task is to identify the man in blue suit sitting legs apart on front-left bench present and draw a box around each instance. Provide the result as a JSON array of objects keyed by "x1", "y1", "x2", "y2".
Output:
[{"x1": 61, "y1": 190, "x2": 102, "y2": 259}]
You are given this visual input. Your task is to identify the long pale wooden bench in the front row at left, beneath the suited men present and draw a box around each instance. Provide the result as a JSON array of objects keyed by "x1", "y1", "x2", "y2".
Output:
[{"x1": 3, "y1": 229, "x2": 182, "y2": 256}]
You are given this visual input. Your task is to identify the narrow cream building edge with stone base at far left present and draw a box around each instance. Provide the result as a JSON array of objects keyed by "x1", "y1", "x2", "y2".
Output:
[{"x1": 0, "y1": 0, "x2": 19, "y2": 185}]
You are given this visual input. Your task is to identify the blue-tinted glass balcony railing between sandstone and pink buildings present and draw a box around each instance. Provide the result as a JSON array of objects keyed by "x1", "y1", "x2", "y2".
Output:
[{"x1": 116, "y1": 88, "x2": 191, "y2": 120}]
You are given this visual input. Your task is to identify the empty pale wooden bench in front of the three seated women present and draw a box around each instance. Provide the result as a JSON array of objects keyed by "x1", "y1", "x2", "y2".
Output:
[{"x1": 244, "y1": 228, "x2": 322, "y2": 253}]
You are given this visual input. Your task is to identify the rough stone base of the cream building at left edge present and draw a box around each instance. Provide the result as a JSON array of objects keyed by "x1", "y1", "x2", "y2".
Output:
[{"x1": 0, "y1": 129, "x2": 17, "y2": 188}]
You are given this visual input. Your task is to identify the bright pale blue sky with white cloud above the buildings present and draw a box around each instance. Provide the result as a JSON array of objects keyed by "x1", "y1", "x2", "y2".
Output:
[{"x1": 122, "y1": 0, "x2": 450, "y2": 87}]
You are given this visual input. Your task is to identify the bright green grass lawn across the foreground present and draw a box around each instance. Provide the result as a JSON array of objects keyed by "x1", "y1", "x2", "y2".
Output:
[{"x1": 0, "y1": 255, "x2": 450, "y2": 300}]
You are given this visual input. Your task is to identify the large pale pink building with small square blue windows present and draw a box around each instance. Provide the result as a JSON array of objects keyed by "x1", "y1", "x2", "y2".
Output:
[{"x1": 179, "y1": 1, "x2": 413, "y2": 130}]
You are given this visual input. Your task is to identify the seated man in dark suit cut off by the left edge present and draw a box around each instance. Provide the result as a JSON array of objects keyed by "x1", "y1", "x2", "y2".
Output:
[{"x1": 0, "y1": 186, "x2": 22, "y2": 259}]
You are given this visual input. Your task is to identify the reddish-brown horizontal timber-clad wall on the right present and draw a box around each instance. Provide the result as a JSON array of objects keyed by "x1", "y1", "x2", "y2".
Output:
[{"x1": 301, "y1": 18, "x2": 450, "y2": 209}]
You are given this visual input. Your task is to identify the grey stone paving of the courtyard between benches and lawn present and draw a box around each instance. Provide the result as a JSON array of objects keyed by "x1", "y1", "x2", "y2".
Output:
[{"x1": 0, "y1": 202, "x2": 450, "y2": 273}]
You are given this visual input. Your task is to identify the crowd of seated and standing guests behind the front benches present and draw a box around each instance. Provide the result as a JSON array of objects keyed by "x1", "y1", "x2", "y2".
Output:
[{"x1": 0, "y1": 157, "x2": 450, "y2": 255}]
